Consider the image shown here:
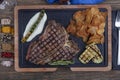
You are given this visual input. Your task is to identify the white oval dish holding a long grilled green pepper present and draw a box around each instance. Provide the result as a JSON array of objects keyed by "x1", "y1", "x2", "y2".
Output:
[{"x1": 21, "y1": 10, "x2": 46, "y2": 43}]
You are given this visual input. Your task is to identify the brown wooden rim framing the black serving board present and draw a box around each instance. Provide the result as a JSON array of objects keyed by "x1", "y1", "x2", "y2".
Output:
[{"x1": 14, "y1": 5, "x2": 112, "y2": 72}]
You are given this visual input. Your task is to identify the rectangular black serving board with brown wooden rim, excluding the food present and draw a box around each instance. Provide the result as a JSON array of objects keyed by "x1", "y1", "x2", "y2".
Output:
[{"x1": 14, "y1": 5, "x2": 111, "y2": 72}]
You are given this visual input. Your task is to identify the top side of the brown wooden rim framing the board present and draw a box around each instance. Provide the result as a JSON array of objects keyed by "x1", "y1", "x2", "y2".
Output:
[{"x1": 13, "y1": 4, "x2": 110, "y2": 10}]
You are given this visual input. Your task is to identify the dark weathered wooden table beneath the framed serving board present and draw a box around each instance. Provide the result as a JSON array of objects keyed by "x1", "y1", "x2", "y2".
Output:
[{"x1": 0, "y1": 0, "x2": 120, "y2": 80}]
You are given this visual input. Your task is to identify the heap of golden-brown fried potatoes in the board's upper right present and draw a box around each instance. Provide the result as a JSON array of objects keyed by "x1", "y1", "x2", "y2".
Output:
[{"x1": 67, "y1": 7, "x2": 107, "y2": 44}]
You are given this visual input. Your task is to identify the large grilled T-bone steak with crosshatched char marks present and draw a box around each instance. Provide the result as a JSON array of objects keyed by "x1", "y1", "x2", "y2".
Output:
[{"x1": 26, "y1": 21, "x2": 79, "y2": 65}]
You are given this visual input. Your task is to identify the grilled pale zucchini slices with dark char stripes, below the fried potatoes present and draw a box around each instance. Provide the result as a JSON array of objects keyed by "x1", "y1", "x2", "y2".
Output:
[{"x1": 79, "y1": 43, "x2": 103, "y2": 64}]
